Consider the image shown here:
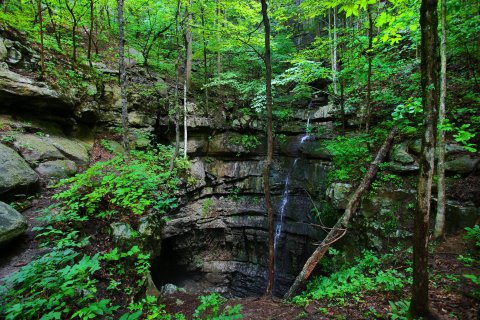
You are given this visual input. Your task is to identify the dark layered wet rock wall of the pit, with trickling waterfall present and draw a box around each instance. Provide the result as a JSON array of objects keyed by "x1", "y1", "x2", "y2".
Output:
[{"x1": 152, "y1": 129, "x2": 330, "y2": 297}]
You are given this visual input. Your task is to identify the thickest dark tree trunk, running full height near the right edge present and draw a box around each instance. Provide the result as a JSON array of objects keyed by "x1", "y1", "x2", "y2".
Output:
[{"x1": 410, "y1": 0, "x2": 438, "y2": 318}]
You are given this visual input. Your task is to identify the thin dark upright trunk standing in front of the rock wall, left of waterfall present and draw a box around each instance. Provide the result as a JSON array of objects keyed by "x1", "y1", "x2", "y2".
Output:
[{"x1": 261, "y1": 0, "x2": 275, "y2": 296}]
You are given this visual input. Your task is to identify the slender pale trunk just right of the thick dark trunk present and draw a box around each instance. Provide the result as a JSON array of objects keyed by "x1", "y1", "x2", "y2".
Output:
[{"x1": 433, "y1": 0, "x2": 447, "y2": 238}]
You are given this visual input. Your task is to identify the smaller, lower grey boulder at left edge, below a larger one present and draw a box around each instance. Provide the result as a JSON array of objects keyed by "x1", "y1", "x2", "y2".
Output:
[{"x1": 0, "y1": 201, "x2": 28, "y2": 245}]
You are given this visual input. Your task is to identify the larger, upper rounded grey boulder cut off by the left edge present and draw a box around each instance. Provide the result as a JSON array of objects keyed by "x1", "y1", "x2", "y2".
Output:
[{"x1": 0, "y1": 144, "x2": 38, "y2": 195}]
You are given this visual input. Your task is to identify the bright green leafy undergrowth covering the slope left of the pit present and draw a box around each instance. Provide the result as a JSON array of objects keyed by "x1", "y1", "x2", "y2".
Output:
[{"x1": 0, "y1": 146, "x2": 244, "y2": 320}]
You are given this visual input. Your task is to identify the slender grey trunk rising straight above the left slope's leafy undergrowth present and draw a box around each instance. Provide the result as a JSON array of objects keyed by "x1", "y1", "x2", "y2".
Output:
[{"x1": 117, "y1": 0, "x2": 130, "y2": 154}]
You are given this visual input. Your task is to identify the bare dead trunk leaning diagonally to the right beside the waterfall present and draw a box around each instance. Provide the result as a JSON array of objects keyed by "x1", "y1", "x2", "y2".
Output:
[{"x1": 284, "y1": 127, "x2": 397, "y2": 299}]
